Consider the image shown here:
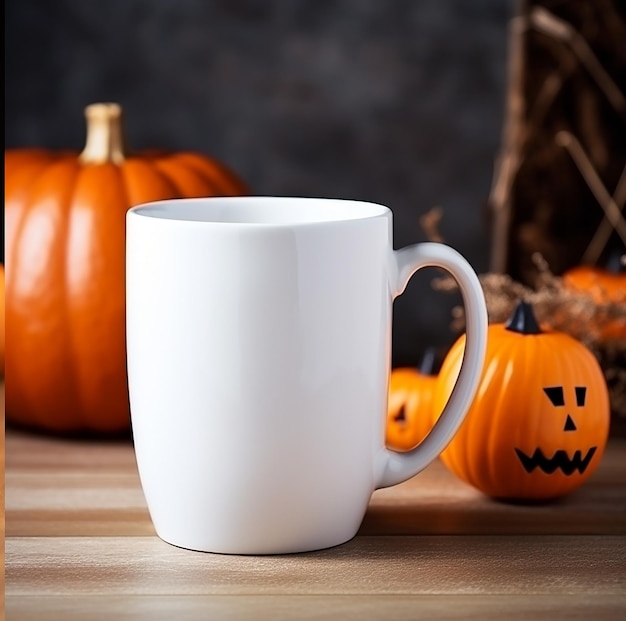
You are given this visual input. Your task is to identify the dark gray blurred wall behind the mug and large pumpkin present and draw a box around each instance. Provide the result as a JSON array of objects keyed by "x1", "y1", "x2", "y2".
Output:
[{"x1": 5, "y1": 0, "x2": 514, "y2": 366}]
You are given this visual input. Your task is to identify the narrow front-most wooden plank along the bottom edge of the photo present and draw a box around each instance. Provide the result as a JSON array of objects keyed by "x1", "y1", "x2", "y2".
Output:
[{"x1": 7, "y1": 594, "x2": 625, "y2": 621}]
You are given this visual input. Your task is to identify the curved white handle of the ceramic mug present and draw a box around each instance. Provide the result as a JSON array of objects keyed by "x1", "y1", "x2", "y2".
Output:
[{"x1": 376, "y1": 242, "x2": 488, "y2": 489}]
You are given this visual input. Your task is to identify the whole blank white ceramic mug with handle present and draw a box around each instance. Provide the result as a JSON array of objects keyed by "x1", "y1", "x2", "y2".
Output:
[{"x1": 127, "y1": 197, "x2": 487, "y2": 554}]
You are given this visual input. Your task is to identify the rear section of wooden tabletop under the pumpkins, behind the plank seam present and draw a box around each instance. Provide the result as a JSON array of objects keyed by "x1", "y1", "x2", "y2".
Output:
[{"x1": 6, "y1": 431, "x2": 626, "y2": 537}]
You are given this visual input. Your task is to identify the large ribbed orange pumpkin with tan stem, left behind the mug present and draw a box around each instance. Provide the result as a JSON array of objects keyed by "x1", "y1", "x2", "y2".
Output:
[{"x1": 4, "y1": 104, "x2": 247, "y2": 433}]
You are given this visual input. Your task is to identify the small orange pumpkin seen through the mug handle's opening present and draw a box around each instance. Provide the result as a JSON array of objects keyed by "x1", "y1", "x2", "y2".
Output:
[{"x1": 386, "y1": 349, "x2": 437, "y2": 451}]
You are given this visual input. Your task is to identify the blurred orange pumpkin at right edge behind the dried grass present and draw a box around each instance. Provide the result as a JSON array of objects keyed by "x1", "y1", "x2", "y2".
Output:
[{"x1": 562, "y1": 256, "x2": 626, "y2": 342}]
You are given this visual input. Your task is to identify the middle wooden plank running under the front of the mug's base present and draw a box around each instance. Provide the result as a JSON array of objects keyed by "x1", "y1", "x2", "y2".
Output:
[{"x1": 7, "y1": 535, "x2": 626, "y2": 596}]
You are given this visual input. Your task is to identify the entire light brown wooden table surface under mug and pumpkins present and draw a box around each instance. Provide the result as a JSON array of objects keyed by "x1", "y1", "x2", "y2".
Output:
[{"x1": 5, "y1": 410, "x2": 626, "y2": 621}]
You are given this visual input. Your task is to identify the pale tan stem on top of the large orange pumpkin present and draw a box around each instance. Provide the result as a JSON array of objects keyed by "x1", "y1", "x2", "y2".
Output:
[{"x1": 79, "y1": 103, "x2": 127, "y2": 164}]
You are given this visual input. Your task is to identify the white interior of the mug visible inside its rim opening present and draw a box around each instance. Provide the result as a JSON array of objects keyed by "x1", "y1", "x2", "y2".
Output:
[{"x1": 130, "y1": 196, "x2": 389, "y2": 224}]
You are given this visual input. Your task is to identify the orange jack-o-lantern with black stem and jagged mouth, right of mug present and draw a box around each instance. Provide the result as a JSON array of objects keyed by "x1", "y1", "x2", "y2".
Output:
[{"x1": 433, "y1": 302, "x2": 610, "y2": 500}]
